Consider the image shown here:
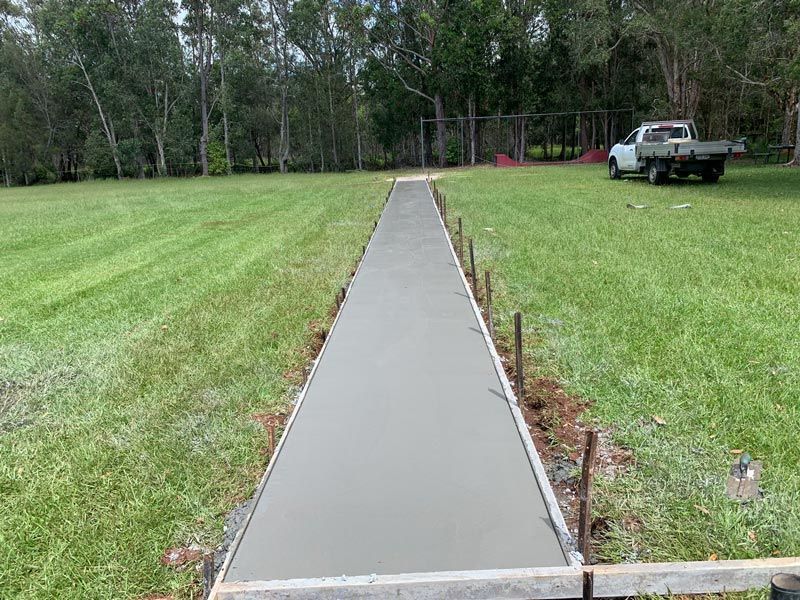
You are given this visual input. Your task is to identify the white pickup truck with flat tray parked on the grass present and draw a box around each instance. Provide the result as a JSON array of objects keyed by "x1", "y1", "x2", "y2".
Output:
[{"x1": 608, "y1": 120, "x2": 746, "y2": 185}]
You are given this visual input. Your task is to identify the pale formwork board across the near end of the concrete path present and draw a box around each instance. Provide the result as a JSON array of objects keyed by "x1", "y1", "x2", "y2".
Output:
[{"x1": 216, "y1": 557, "x2": 800, "y2": 600}]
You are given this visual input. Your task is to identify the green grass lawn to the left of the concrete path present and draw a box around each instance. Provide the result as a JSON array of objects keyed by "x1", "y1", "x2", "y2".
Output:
[{"x1": 0, "y1": 174, "x2": 390, "y2": 598}]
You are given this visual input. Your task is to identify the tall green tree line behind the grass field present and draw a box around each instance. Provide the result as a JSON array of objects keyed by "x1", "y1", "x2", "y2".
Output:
[{"x1": 0, "y1": 0, "x2": 800, "y2": 185}]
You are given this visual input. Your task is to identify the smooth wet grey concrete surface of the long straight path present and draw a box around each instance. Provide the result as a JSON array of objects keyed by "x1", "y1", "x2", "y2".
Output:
[{"x1": 225, "y1": 181, "x2": 568, "y2": 582}]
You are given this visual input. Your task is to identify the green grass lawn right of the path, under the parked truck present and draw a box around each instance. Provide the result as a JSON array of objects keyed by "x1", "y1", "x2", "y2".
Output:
[{"x1": 438, "y1": 165, "x2": 800, "y2": 561}]
